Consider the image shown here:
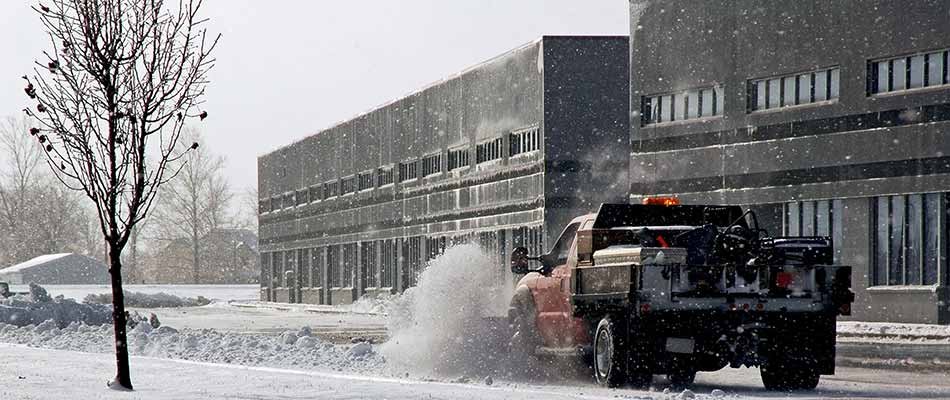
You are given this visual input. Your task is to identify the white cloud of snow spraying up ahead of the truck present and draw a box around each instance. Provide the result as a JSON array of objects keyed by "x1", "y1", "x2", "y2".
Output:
[{"x1": 380, "y1": 244, "x2": 512, "y2": 376}]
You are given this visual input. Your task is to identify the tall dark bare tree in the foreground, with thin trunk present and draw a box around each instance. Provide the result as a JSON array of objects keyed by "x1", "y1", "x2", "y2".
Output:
[{"x1": 24, "y1": 0, "x2": 220, "y2": 390}]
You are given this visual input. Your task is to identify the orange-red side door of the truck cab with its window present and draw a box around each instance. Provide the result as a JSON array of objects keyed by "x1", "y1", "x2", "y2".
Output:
[{"x1": 533, "y1": 222, "x2": 580, "y2": 347}]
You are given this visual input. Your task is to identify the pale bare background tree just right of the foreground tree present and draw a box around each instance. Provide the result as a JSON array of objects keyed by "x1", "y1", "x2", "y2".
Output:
[{"x1": 153, "y1": 130, "x2": 233, "y2": 283}]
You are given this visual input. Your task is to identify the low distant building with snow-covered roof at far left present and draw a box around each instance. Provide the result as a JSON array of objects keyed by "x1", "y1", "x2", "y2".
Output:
[{"x1": 0, "y1": 253, "x2": 110, "y2": 285}]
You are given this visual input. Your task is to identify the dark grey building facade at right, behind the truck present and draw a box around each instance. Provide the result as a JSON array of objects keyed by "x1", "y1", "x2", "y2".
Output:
[{"x1": 630, "y1": 0, "x2": 950, "y2": 323}]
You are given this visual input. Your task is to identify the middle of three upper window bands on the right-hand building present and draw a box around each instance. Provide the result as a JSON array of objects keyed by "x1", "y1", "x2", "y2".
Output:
[{"x1": 748, "y1": 67, "x2": 841, "y2": 111}]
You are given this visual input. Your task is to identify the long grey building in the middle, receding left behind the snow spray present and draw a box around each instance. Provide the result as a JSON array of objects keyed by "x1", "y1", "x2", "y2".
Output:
[{"x1": 258, "y1": 36, "x2": 630, "y2": 304}]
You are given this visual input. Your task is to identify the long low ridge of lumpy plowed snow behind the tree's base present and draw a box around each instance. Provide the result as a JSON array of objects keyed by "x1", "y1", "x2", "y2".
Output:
[{"x1": 0, "y1": 321, "x2": 385, "y2": 373}]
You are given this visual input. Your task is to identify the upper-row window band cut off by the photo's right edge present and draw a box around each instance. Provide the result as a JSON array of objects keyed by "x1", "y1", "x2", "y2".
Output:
[{"x1": 868, "y1": 49, "x2": 950, "y2": 94}]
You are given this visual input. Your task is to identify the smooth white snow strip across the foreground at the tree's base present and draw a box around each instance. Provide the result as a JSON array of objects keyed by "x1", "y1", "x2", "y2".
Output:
[{"x1": 0, "y1": 344, "x2": 950, "y2": 400}]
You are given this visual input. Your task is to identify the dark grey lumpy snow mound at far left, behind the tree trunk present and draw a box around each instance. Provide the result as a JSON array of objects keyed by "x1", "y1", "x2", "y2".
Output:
[{"x1": 0, "y1": 283, "x2": 112, "y2": 328}]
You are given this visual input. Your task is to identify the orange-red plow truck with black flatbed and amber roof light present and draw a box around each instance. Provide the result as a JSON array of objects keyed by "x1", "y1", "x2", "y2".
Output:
[{"x1": 508, "y1": 199, "x2": 854, "y2": 390}]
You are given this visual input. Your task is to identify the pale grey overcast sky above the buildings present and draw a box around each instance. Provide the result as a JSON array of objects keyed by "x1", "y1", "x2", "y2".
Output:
[{"x1": 0, "y1": 0, "x2": 629, "y2": 189}]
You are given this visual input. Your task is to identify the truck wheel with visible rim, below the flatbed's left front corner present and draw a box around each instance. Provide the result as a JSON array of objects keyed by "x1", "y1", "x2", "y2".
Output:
[{"x1": 594, "y1": 316, "x2": 628, "y2": 387}]
